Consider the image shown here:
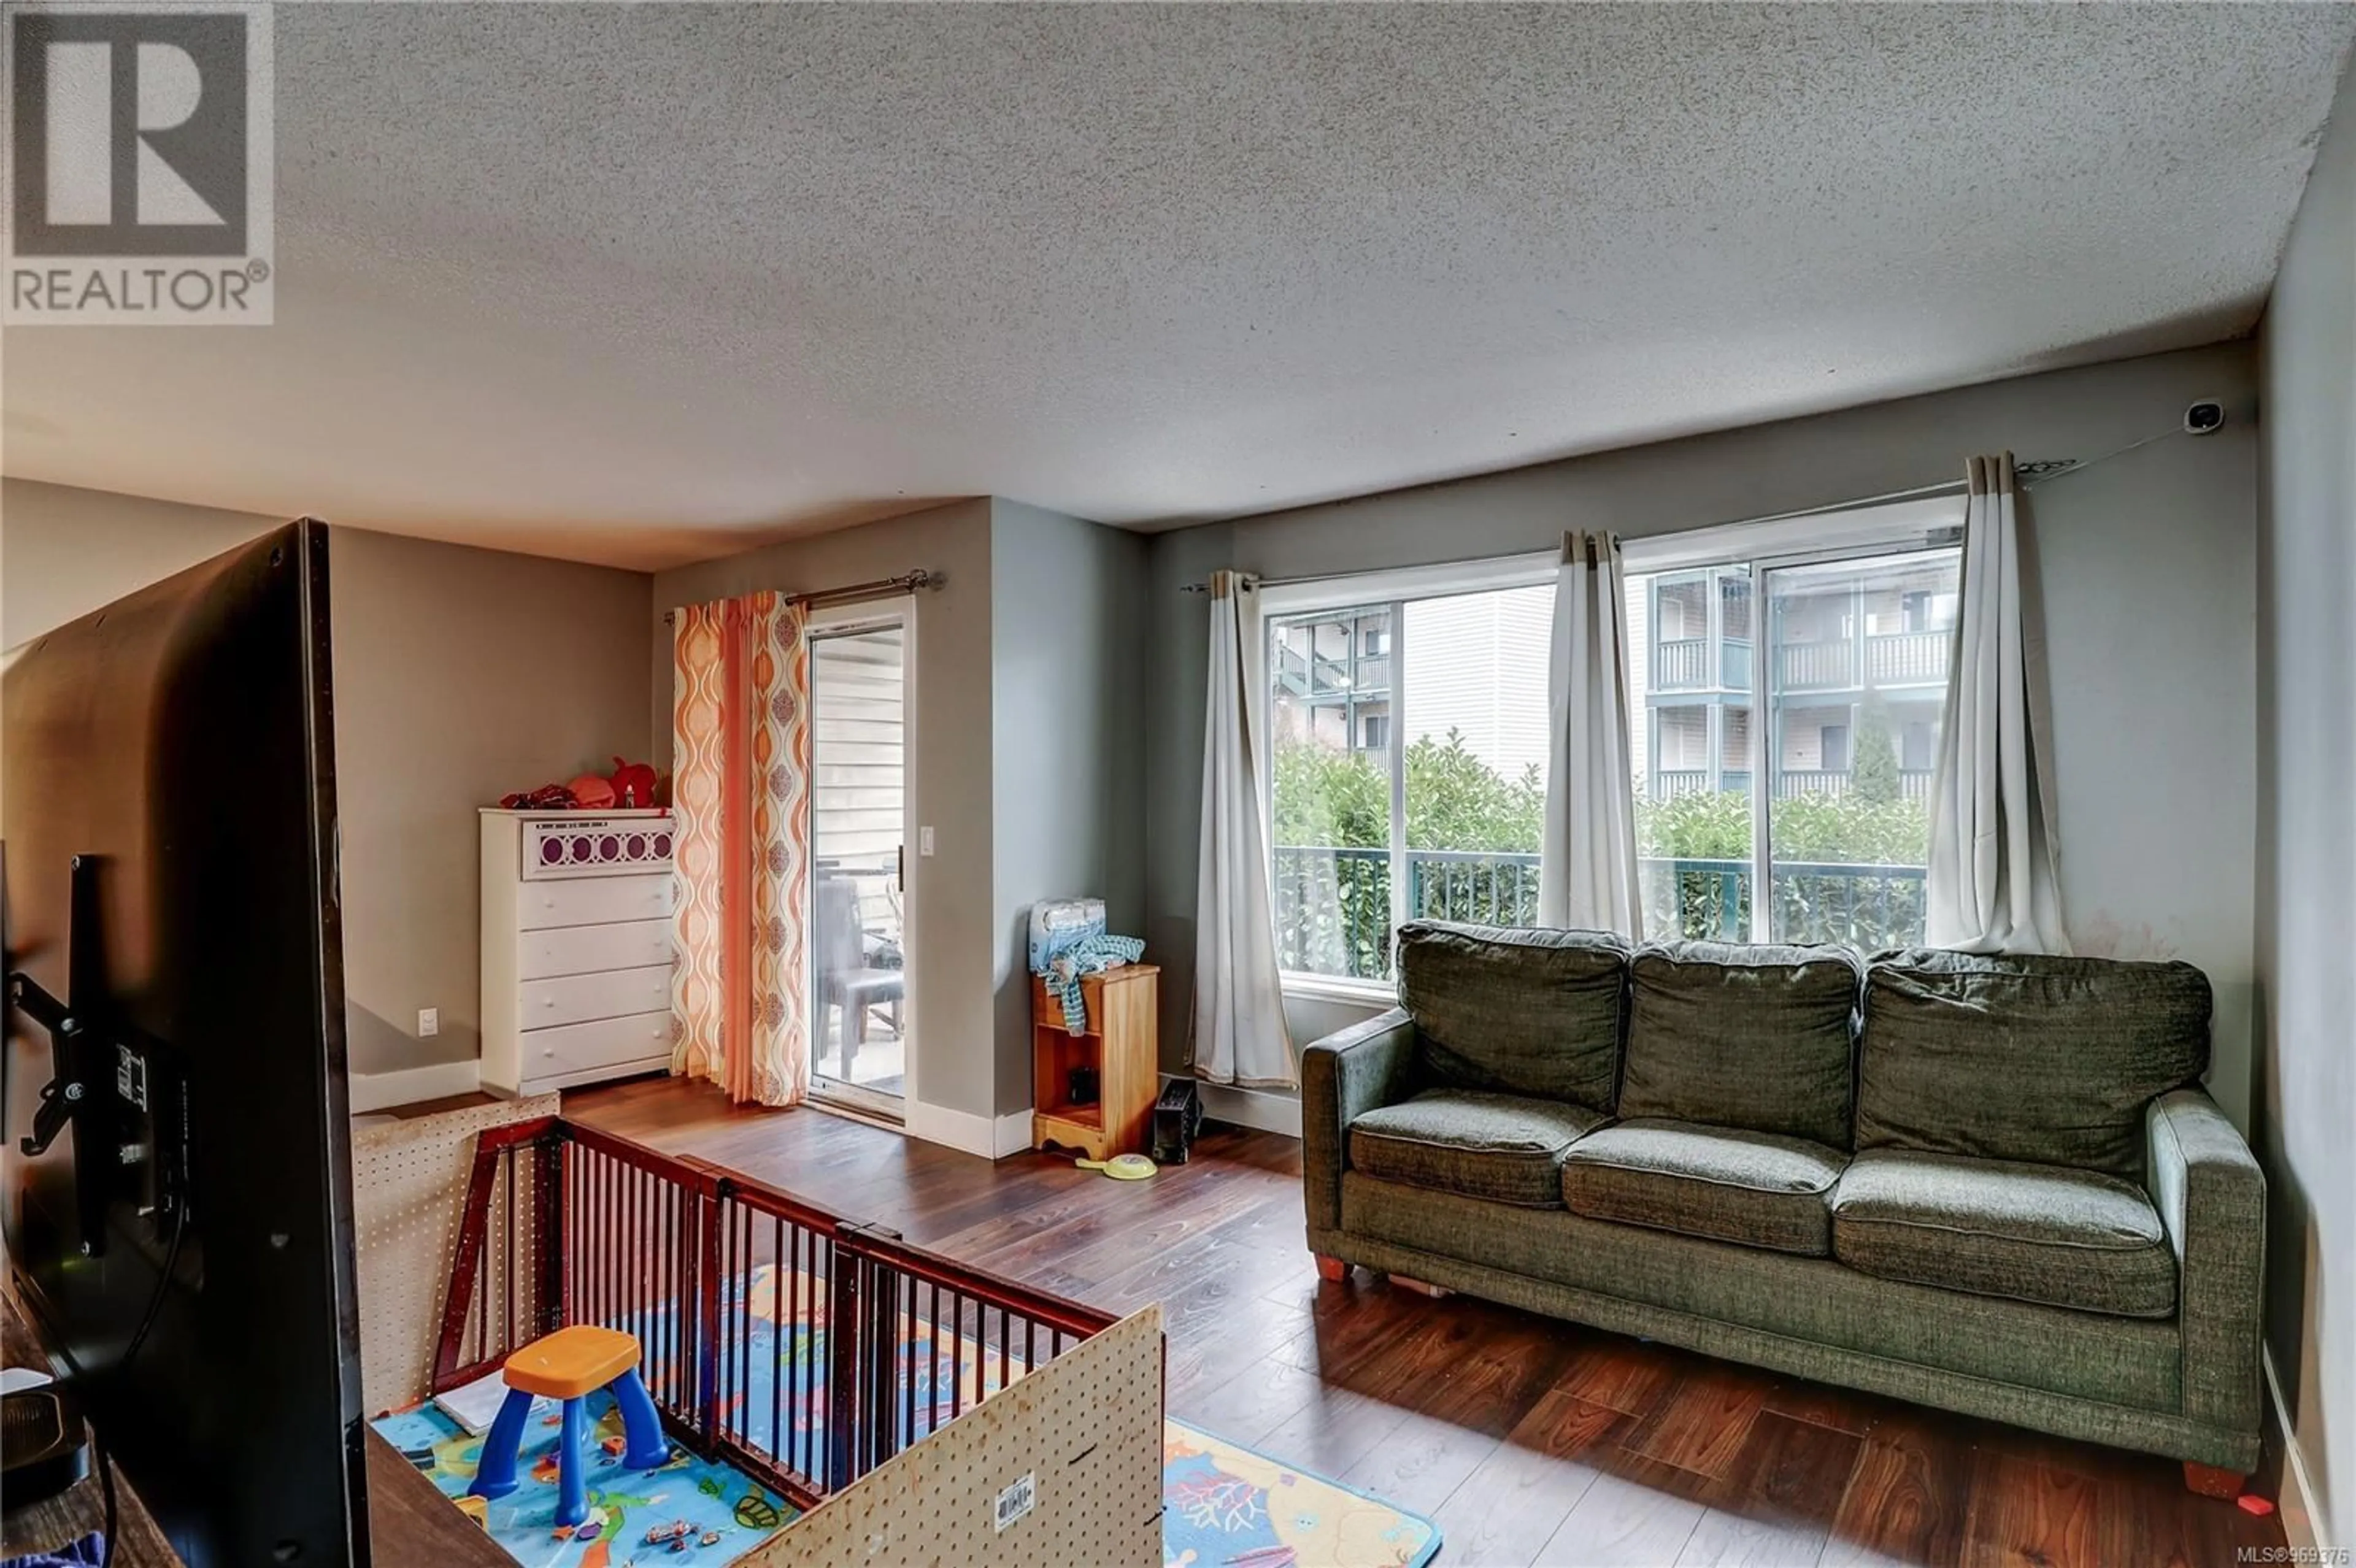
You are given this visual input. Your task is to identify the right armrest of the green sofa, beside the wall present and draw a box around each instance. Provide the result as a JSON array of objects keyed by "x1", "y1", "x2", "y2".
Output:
[{"x1": 2144, "y1": 1088, "x2": 2266, "y2": 1431}]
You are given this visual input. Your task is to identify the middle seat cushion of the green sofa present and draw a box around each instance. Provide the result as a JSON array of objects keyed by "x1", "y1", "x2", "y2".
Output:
[{"x1": 1562, "y1": 1118, "x2": 1849, "y2": 1257}]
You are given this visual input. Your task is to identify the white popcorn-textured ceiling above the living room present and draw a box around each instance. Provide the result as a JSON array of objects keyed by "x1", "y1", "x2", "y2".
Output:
[{"x1": 0, "y1": 5, "x2": 2356, "y2": 567}]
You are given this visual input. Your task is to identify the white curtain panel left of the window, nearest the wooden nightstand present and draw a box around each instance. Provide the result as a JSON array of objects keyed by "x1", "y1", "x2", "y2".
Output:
[{"x1": 1195, "y1": 572, "x2": 1301, "y2": 1088}]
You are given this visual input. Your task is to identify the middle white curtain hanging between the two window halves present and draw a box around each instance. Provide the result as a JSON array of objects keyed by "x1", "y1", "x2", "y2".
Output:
[{"x1": 1539, "y1": 532, "x2": 1644, "y2": 939}]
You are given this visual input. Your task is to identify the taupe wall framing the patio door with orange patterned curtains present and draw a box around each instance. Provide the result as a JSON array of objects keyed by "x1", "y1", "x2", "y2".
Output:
[{"x1": 641, "y1": 501, "x2": 999, "y2": 1116}]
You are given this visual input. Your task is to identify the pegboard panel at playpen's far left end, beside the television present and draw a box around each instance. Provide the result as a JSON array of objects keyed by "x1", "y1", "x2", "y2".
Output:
[{"x1": 351, "y1": 1095, "x2": 561, "y2": 1415}]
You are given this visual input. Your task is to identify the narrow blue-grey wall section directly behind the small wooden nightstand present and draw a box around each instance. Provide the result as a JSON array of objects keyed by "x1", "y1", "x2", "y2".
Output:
[{"x1": 990, "y1": 499, "x2": 1159, "y2": 1116}]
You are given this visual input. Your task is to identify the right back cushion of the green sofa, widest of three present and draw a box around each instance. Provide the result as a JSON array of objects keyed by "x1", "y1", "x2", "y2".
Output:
[{"x1": 1857, "y1": 951, "x2": 2210, "y2": 1182}]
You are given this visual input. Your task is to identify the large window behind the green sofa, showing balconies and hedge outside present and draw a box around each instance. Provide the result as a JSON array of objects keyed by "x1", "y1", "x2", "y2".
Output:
[{"x1": 1263, "y1": 515, "x2": 1960, "y2": 986}]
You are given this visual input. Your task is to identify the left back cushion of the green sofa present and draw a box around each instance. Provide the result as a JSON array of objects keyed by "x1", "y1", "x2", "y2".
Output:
[{"x1": 1399, "y1": 921, "x2": 1628, "y2": 1111}]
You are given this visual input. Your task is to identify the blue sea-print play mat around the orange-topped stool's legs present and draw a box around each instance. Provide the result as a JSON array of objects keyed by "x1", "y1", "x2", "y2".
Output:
[{"x1": 375, "y1": 1391, "x2": 799, "y2": 1568}]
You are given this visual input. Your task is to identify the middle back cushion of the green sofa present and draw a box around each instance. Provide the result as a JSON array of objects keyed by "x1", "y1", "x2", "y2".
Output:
[{"x1": 1619, "y1": 942, "x2": 1863, "y2": 1149}]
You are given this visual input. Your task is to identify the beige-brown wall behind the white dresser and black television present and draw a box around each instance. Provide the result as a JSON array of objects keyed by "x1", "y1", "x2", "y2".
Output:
[{"x1": 0, "y1": 480, "x2": 650, "y2": 1074}]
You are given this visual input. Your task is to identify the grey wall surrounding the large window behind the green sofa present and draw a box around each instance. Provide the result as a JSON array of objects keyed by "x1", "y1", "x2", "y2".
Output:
[{"x1": 1147, "y1": 344, "x2": 2257, "y2": 1123}]
